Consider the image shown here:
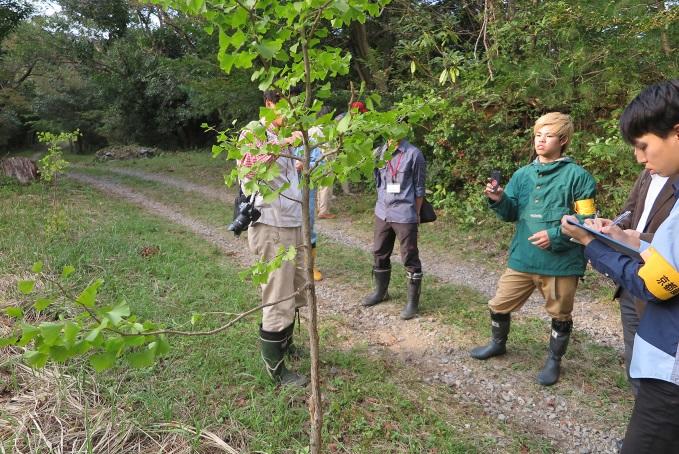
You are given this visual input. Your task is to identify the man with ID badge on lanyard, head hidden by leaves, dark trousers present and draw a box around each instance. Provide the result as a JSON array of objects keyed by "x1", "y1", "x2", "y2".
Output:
[{"x1": 363, "y1": 139, "x2": 426, "y2": 320}]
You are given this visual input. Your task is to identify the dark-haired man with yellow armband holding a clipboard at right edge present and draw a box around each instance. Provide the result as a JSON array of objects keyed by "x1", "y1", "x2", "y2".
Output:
[{"x1": 561, "y1": 79, "x2": 679, "y2": 454}]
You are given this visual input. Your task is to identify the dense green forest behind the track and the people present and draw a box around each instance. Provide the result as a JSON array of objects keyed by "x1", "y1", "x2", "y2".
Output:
[{"x1": 0, "y1": 0, "x2": 679, "y2": 220}]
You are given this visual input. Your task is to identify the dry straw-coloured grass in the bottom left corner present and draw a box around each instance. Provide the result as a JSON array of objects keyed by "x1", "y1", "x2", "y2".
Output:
[{"x1": 0, "y1": 275, "x2": 247, "y2": 454}]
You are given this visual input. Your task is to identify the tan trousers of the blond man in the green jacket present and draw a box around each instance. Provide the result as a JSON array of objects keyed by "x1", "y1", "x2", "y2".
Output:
[{"x1": 488, "y1": 268, "x2": 579, "y2": 321}]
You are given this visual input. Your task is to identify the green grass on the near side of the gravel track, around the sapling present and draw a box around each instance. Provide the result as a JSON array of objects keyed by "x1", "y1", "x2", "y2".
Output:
[{"x1": 0, "y1": 175, "x2": 556, "y2": 453}]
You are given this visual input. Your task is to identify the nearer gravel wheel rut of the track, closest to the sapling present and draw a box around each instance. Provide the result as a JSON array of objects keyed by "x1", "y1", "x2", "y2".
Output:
[{"x1": 69, "y1": 170, "x2": 624, "y2": 454}]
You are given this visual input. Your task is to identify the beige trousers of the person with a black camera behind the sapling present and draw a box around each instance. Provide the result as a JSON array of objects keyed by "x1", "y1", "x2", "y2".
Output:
[{"x1": 248, "y1": 223, "x2": 306, "y2": 333}]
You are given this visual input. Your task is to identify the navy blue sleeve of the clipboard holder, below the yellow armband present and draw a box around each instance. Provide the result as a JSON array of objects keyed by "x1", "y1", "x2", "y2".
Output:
[{"x1": 585, "y1": 240, "x2": 662, "y2": 303}]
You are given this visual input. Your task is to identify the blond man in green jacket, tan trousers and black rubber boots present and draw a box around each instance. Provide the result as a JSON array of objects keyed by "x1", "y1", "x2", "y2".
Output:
[{"x1": 470, "y1": 112, "x2": 596, "y2": 386}]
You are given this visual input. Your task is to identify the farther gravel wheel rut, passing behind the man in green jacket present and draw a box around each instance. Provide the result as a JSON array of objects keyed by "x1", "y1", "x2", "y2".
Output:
[{"x1": 98, "y1": 167, "x2": 623, "y2": 352}]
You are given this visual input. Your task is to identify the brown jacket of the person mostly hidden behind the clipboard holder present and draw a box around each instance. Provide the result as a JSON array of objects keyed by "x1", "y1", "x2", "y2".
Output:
[{"x1": 613, "y1": 170, "x2": 679, "y2": 304}]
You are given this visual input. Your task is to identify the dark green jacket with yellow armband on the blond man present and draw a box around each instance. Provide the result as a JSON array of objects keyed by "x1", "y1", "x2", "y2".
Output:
[{"x1": 490, "y1": 157, "x2": 596, "y2": 276}]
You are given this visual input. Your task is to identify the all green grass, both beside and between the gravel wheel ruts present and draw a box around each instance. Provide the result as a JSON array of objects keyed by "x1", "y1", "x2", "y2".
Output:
[{"x1": 0, "y1": 153, "x2": 631, "y2": 453}]
